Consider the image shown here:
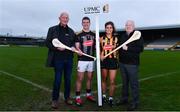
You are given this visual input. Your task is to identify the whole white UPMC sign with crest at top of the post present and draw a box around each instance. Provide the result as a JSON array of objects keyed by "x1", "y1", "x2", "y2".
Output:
[{"x1": 84, "y1": 4, "x2": 109, "y2": 14}]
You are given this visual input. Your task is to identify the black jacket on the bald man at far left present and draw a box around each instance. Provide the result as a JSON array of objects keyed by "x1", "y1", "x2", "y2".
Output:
[{"x1": 46, "y1": 25, "x2": 76, "y2": 67}]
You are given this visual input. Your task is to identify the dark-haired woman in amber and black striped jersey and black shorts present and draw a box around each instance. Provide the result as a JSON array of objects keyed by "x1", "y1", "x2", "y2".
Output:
[{"x1": 100, "y1": 21, "x2": 118, "y2": 106}]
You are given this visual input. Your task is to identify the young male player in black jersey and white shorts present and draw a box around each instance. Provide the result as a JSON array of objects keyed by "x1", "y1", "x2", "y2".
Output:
[{"x1": 75, "y1": 17, "x2": 96, "y2": 106}]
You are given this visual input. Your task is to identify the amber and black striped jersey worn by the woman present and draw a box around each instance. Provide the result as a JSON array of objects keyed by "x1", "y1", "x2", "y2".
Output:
[{"x1": 100, "y1": 36, "x2": 118, "y2": 58}]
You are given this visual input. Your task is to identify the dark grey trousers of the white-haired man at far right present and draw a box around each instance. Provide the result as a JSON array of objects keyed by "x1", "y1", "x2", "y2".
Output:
[{"x1": 120, "y1": 63, "x2": 139, "y2": 104}]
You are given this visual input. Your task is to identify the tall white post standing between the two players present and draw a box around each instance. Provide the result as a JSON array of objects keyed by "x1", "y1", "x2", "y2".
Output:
[{"x1": 95, "y1": 14, "x2": 102, "y2": 106}]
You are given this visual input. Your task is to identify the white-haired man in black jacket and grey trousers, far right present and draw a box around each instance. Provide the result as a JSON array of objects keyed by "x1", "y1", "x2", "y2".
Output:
[{"x1": 118, "y1": 20, "x2": 143, "y2": 110}]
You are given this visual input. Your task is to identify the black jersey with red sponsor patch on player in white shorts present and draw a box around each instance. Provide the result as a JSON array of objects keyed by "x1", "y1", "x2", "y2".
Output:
[{"x1": 76, "y1": 31, "x2": 95, "y2": 61}]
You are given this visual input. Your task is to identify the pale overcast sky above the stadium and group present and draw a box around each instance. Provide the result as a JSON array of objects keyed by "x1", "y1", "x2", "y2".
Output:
[{"x1": 0, "y1": 0, "x2": 180, "y2": 37}]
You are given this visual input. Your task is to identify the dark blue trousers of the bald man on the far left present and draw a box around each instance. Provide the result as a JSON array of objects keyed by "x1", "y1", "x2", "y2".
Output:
[{"x1": 52, "y1": 59, "x2": 73, "y2": 101}]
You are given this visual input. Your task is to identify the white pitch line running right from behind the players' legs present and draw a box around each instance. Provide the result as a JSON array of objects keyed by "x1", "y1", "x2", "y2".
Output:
[{"x1": 76, "y1": 71, "x2": 180, "y2": 98}]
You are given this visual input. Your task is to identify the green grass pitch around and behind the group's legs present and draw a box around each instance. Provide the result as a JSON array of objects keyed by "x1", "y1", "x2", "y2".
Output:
[{"x1": 0, "y1": 47, "x2": 180, "y2": 111}]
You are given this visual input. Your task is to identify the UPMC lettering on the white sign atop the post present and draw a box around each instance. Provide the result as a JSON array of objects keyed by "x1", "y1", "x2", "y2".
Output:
[{"x1": 84, "y1": 6, "x2": 100, "y2": 14}]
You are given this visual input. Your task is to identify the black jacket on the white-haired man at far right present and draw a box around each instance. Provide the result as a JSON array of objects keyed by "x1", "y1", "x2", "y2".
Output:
[{"x1": 119, "y1": 31, "x2": 144, "y2": 65}]
